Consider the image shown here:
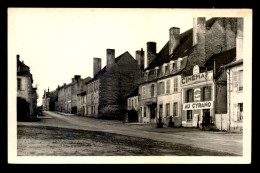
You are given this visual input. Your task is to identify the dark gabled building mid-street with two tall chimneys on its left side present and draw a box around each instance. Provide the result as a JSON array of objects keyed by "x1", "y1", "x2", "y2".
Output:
[{"x1": 86, "y1": 49, "x2": 140, "y2": 119}]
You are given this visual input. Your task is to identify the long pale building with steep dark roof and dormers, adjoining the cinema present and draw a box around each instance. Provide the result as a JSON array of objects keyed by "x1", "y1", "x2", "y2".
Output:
[{"x1": 139, "y1": 17, "x2": 242, "y2": 126}]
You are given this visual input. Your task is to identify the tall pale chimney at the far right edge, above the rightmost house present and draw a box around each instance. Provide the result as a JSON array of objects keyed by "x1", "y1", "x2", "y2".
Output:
[{"x1": 236, "y1": 18, "x2": 244, "y2": 60}]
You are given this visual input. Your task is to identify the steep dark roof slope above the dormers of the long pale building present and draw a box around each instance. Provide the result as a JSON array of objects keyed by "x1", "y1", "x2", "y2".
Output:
[{"x1": 145, "y1": 18, "x2": 219, "y2": 70}]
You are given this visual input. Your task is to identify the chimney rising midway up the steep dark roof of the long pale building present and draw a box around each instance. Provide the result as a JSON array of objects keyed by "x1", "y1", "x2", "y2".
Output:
[{"x1": 169, "y1": 27, "x2": 180, "y2": 55}]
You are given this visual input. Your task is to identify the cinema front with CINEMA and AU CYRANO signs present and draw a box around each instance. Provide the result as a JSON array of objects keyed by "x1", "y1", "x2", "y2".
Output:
[{"x1": 181, "y1": 66, "x2": 215, "y2": 128}]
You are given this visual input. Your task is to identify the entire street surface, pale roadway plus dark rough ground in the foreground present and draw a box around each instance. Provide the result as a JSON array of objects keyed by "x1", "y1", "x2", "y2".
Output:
[{"x1": 17, "y1": 111, "x2": 243, "y2": 156}]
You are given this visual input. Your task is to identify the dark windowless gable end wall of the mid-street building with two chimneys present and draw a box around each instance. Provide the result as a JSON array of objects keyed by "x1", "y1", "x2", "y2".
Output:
[{"x1": 98, "y1": 52, "x2": 140, "y2": 119}]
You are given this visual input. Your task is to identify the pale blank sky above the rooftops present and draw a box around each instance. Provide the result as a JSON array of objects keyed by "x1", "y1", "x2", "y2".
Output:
[{"x1": 8, "y1": 8, "x2": 248, "y2": 105}]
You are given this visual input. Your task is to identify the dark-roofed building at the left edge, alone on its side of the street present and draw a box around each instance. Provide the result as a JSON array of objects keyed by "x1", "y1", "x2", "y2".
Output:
[{"x1": 17, "y1": 55, "x2": 38, "y2": 120}]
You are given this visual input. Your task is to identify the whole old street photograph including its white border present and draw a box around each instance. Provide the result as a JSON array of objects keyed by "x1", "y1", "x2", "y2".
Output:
[{"x1": 8, "y1": 8, "x2": 252, "y2": 164}]
